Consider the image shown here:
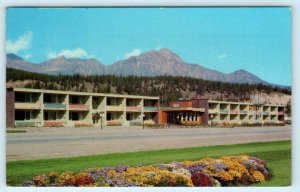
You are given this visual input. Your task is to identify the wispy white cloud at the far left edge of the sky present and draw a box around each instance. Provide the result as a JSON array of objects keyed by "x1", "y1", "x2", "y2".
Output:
[{"x1": 6, "y1": 31, "x2": 32, "y2": 54}]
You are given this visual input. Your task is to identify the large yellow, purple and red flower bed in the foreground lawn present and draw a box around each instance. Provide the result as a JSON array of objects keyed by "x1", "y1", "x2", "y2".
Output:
[{"x1": 22, "y1": 155, "x2": 271, "y2": 187}]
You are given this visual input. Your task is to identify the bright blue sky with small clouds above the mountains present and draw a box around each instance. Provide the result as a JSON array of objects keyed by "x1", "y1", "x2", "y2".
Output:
[{"x1": 6, "y1": 7, "x2": 292, "y2": 85}]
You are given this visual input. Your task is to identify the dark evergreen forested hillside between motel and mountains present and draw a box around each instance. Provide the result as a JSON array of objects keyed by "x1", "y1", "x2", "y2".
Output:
[{"x1": 6, "y1": 68, "x2": 291, "y2": 106}]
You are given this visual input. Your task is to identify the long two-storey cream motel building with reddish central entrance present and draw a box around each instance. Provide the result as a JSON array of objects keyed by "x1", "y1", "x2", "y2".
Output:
[{"x1": 6, "y1": 88, "x2": 284, "y2": 127}]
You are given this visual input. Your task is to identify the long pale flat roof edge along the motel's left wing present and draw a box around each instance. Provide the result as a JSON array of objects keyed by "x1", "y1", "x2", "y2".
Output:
[{"x1": 13, "y1": 88, "x2": 159, "y2": 100}]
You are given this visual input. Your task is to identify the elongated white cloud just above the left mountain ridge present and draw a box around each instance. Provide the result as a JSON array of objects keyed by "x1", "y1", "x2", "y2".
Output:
[{"x1": 47, "y1": 48, "x2": 93, "y2": 59}]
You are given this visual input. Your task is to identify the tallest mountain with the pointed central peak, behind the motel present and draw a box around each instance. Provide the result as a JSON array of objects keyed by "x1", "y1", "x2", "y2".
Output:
[{"x1": 107, "y1": 49, "x2": 226, "y2": 81}]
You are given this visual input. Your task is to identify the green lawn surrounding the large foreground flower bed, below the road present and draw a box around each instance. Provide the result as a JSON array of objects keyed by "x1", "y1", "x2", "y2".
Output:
[{"x1": 7, "y1": 141, "x2": 291, "y2": 186}]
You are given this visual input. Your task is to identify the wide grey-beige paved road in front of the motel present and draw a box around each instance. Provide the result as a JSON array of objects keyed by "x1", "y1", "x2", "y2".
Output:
[{"x1": 6, "y1": 126, "x2": 291, "y2": 161}]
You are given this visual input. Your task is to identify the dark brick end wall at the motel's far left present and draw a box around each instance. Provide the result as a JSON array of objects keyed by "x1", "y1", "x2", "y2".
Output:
[{"x1": 6, "y1": 89, "x2": 15, "y2": 127}]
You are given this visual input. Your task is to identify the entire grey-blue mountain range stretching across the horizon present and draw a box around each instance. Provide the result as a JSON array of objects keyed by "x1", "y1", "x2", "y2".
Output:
[{"x1": 7, "y1": 48, "x2": 267, "y2": 84}]
